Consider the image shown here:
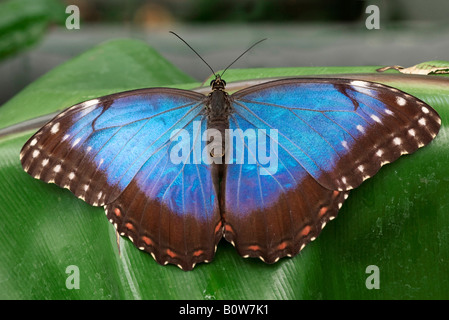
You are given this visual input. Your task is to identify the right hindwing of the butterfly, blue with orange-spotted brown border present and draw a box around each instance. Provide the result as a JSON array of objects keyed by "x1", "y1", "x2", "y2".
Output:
[{"x1": 221, "y1": 113, "x2": 346, "y2": 263}]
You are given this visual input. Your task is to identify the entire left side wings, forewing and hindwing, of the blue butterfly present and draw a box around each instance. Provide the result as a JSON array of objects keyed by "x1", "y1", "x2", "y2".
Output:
[{"x1": 21, "y1": 88, "x2": 222, "y2": 270}]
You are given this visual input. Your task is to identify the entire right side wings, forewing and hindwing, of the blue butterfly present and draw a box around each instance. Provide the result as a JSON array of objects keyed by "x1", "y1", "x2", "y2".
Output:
[{"x1": 221, "y1": 79, "x2": 441, "y2": 263}]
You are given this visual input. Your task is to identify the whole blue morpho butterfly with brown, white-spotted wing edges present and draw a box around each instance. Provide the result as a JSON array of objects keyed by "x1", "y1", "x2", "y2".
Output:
[{"x1": 21, "y1": 33, "x2": 441, "y2": 270}]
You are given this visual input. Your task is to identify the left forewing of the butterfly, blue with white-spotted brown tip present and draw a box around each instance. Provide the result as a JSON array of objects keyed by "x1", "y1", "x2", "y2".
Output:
[{"x1": 21, "y1": 89, "x2": 203, "y2": 205}]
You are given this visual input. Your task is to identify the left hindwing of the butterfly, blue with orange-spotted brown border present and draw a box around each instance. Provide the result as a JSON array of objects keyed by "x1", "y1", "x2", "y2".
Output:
[{"x1": 105, "y1": 116, "x2": 222, "y2": 270}]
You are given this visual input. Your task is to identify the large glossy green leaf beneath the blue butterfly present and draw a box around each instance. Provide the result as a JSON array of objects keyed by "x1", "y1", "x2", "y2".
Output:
[{"x1": 0, "y1": 40, "x2": 449, "y2": 299}]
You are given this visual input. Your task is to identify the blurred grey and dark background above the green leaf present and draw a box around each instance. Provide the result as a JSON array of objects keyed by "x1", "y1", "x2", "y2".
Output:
[{"x1": 0, "y1": 0, "x2": 449, "y2": 105}]
